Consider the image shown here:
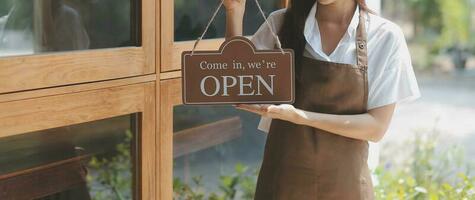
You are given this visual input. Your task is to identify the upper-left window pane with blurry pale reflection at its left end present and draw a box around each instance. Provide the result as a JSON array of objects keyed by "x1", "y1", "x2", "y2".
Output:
[{"x1": 0, "y1": 0, "x2": 140, "y2": 57}]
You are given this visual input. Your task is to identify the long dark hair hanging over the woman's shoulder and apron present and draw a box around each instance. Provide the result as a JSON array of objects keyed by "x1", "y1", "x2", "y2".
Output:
[{"x1": 278, "y1": 0, "x2": 371, "y2": 80}]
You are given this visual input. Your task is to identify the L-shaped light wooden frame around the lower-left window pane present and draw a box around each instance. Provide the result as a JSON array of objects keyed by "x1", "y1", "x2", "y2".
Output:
[{"x1": 0, "y1": 82, "x2": 157, "y2": 200}]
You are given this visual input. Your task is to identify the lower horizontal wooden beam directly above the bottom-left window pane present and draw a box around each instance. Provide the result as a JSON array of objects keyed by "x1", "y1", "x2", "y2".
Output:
[{"x1": 0, "y1": 84, "x2": 147, "y2": 138}]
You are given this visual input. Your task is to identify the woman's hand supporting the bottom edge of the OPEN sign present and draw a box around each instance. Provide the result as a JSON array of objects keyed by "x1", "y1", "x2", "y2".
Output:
[{"x1": 236, "y1": 104, "x2": 305, "y2": 124}]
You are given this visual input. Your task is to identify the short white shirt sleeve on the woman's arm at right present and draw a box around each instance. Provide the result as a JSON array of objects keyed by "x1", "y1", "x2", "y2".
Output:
[{"x1": 368, "y1": 28, "x2": 420, "y2": 109}]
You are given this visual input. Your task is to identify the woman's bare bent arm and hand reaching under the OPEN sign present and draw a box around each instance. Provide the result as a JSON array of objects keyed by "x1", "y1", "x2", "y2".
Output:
[{"x1": 237, "y1": 104, "x2": 396, "y2": 142}]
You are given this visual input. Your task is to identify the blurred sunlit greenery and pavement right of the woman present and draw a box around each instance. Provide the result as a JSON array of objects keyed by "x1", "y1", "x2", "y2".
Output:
[{"x1": 375, "y1": 0, "x2": 475, "y2": 199}]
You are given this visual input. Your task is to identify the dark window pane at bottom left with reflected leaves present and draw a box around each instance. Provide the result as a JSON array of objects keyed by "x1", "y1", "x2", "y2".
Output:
[{"x1": 0, "y1": 114, "x2": 139, "y2": 200}]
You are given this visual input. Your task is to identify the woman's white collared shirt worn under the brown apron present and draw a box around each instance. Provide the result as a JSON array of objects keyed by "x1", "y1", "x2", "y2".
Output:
[{"x1": 251, "y1": 3, "x2": 420, "y2": 132}]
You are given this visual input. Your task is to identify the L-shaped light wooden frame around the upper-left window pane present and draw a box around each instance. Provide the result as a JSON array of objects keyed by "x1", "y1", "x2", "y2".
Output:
[{"x1": 0, "y1": 0, "x2": 156, "y2": 94}]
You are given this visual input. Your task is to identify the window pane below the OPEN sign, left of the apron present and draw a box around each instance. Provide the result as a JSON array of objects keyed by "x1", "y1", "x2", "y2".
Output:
[{"x1": 173, "y1": 105, "x2": 266, "y2": 199}]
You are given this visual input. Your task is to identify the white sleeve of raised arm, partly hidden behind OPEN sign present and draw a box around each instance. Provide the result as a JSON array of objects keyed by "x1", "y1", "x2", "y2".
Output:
[{"x1": 251, "y1": 9, "x2": 285, "y2": 133}]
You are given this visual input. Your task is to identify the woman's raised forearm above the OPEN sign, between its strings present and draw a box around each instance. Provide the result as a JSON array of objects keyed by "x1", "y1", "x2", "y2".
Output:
[{"x1": 223, "y1": 0, "x2": 246, "y2": 38}]
